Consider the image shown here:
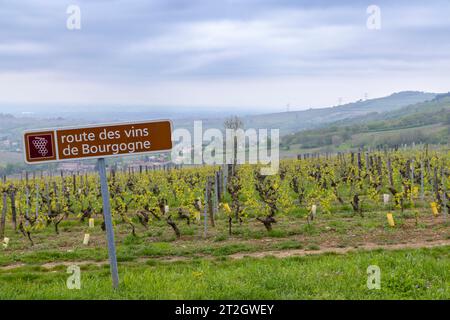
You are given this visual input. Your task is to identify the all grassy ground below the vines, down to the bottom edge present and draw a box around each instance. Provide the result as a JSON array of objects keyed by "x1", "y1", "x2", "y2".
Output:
[{"x1": 0, "y1": 202, "x2": 450, "y2": 299}]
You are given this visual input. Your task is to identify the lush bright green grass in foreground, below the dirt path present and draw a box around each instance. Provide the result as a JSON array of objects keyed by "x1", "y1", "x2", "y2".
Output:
[{"x1": 0, "y1": 246, "x2": 450, "y2": 299}]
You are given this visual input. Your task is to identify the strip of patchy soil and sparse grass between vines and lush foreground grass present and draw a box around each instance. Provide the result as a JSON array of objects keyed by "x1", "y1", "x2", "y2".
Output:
[{"x1": 0, "y1": 208, "x2": 450, "y2": 273}]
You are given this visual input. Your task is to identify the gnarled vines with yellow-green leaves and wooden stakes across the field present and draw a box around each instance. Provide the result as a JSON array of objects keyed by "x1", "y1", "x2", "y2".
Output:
[{"x1": 0, "y1": 150, "x2": 449, "y2": 245}]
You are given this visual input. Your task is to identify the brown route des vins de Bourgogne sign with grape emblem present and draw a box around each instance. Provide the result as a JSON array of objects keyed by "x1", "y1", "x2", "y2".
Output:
[{"x1": 24, "y1": 120, "x2": 172, "y2": 164}]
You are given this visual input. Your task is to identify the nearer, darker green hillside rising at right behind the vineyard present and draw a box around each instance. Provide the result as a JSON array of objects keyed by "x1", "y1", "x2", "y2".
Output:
[{"x1": 281, "y1": 93, "x2": 450, "y2": 151}]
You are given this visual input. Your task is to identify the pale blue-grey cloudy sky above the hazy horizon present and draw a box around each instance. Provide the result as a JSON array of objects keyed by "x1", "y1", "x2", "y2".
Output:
[{"x1": 0, "y1": 0, "x2": 450, "y2": 111}]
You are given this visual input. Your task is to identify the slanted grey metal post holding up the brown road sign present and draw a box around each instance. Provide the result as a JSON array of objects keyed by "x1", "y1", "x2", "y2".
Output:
[{"x1": 98, "y1": 158, "x2": 119, "y2": 289}]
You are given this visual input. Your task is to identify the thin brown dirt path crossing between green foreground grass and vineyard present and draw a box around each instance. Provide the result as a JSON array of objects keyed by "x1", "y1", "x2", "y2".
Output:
[{"x1": 0, "y1": 240, "x2": 450, "y2": 271}]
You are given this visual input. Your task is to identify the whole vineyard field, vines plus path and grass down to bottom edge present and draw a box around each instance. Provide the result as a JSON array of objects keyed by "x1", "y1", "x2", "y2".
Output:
[{"x1": 0, "y1": 149, "x2": 450, "y2": 298}]
